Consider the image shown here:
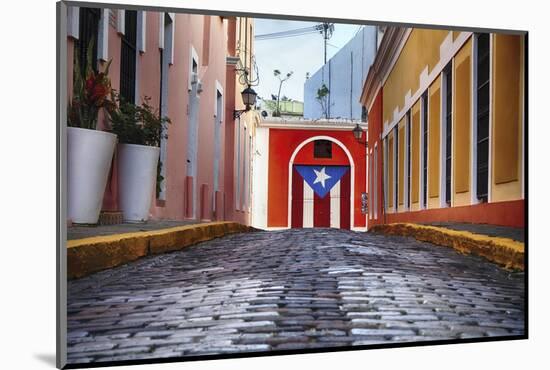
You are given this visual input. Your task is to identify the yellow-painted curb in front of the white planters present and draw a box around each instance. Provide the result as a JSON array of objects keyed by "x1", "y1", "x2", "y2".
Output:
[{"x1": 67, "y1": 221, "x2": 254, "y2": 279}]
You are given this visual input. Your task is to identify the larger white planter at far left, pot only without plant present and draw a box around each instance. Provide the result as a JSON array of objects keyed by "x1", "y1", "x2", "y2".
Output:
[{"x1": 67, "y1": 127, "x2": 117, "y2": 224}]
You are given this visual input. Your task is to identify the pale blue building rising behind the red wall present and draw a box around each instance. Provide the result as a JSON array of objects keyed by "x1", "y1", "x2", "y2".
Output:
[{"x1": 304, "y1": 26, "x2": 377, "y2": 121}]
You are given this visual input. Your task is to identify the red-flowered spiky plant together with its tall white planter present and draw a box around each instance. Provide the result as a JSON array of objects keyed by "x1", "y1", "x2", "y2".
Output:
[{"x1": 67, "y1": 40, "x2": 116, "y2": 224}]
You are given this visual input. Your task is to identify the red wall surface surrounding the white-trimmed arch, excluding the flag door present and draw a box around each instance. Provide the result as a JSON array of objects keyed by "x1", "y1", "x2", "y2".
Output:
[{"x1": 267, "y1": 129, "x2": 366, "y2": 227}]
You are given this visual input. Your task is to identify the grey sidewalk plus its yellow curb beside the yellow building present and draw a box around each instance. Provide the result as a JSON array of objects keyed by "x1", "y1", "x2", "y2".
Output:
[{"x1": 370, "y1": 222, "x2": 525, "y2": 271}]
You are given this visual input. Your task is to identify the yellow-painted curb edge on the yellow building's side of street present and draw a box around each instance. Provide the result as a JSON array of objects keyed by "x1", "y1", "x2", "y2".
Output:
[{"x1": 371, "y1": 223, "x2": 525, "y2": 271}]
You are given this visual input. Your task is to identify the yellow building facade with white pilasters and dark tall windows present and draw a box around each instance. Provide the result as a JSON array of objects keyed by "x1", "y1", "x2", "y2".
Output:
[{"x1": 361, "y1": 27, "x2": 526, "y2": 227}]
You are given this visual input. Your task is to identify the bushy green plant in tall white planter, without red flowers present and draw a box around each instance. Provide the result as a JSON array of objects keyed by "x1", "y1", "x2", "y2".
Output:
[{"x1": 109, "y1": 96, "x2": 170, "y2": 222}]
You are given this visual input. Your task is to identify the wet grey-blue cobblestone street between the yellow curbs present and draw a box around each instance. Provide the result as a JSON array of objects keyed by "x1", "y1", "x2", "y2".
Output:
[{"x1": 68, "y1": 229, "x2": 524, "y2": 363}]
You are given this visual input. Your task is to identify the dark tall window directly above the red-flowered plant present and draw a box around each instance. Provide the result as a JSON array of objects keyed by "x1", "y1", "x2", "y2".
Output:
[{"x1": 75, "y1": 8, "x2": 101, "y2": 74}]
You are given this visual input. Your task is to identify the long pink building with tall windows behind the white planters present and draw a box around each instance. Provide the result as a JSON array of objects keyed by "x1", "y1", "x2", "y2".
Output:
[{"x1": 67, "y1": 7, "x2": 256, "y2": 224}]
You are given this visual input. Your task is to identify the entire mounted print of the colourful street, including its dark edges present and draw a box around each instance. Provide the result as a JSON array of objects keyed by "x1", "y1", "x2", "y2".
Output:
[{"x1": 57, "y1": 1, "x2": 528, "y2": 368}]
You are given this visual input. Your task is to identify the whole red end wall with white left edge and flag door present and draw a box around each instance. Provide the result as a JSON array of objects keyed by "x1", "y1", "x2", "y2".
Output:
[{"x1": 252, "y1": 119, "x2": 367, "y2": 230}]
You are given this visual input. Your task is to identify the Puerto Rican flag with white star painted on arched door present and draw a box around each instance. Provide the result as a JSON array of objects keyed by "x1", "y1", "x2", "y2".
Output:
[{"x1": 291, "y1": 165, "x2": 351, "y2": 229}]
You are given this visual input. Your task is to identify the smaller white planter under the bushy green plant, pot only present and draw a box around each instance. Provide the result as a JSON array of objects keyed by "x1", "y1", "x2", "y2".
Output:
[{"x1": 118, "y1": 144, "x2": 160, "y2": 222}]
